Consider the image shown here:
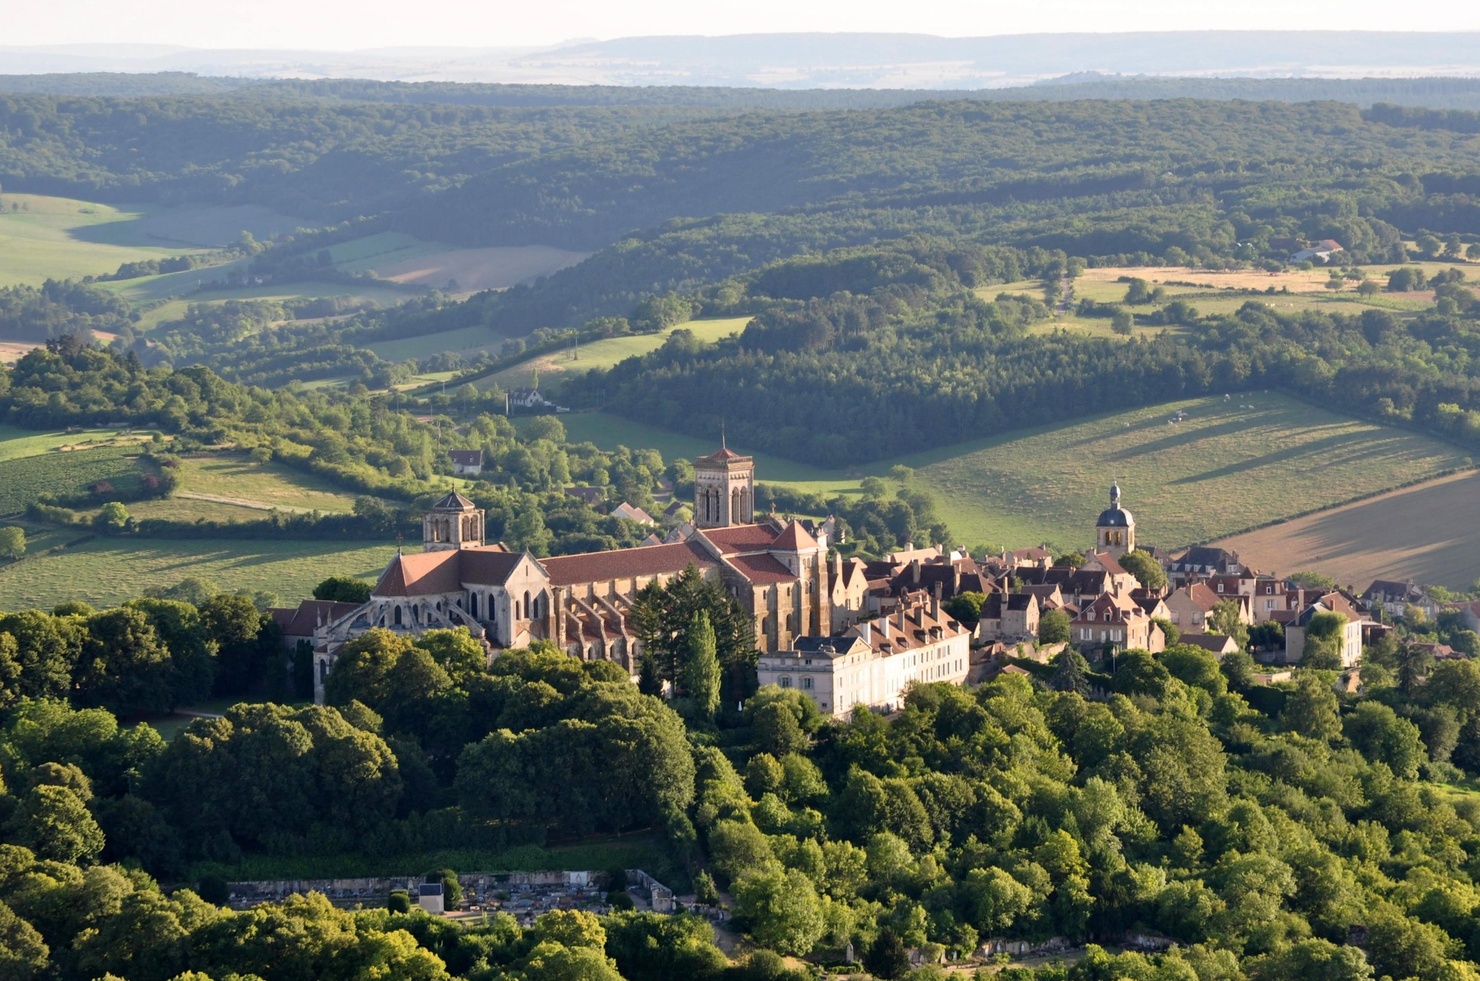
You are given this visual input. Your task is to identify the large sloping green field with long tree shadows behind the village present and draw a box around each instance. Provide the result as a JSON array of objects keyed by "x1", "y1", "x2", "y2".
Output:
[{"x1": 561, "y1": 392, "x2": 1480, "y2": 568}]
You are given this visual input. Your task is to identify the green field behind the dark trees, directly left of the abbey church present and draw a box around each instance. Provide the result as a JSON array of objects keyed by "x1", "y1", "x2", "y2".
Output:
[{"x1": 0, "y1": 527, "x2": 395, "y2": 610}]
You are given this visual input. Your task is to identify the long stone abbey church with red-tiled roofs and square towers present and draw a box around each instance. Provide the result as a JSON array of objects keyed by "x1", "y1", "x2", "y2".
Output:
[{"x1": 314, "y1": 447, "x2": 842, "y2": 701}]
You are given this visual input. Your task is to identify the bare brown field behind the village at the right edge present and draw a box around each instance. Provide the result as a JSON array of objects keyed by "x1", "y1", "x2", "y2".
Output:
[{"x1": 1218, "y1": 471, "x2": 1480, "y2": 590}]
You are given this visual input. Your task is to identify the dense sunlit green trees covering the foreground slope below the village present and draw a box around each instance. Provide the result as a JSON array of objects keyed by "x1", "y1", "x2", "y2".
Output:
[{"x1": 0, "y1": 609, "x2": 1480, "y2": 981}]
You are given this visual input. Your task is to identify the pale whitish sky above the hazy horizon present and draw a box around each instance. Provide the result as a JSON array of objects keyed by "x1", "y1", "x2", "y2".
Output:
[{"x1": 11, "y1": 0, "x2": 1480, "y2": 50}]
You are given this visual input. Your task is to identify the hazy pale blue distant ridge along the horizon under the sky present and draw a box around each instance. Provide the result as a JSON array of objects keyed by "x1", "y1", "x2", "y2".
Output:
[{"x1": 0, "y1": 31, "x2": 1480, "y2": 90}]
